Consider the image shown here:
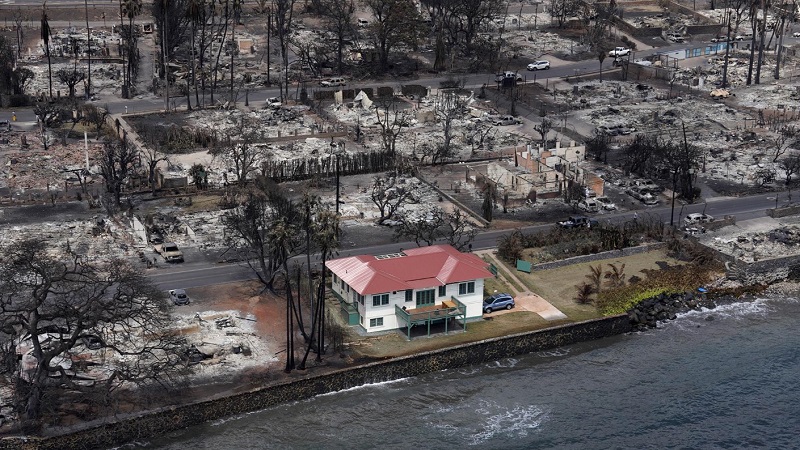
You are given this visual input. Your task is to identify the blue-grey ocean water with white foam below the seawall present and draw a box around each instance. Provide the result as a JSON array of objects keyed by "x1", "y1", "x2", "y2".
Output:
[{"x1": 139, "y1": 298, "x2": 800, "y2": 449}]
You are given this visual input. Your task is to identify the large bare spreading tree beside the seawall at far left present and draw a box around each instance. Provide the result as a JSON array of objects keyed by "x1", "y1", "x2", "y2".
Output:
[{"x1": 0, "y1": 240, "x2": 181, "y2": 421}]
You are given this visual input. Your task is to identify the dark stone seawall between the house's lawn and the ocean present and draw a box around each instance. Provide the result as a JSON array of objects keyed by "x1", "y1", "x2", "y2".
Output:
[{"x1": 0, "y1": 315, "x2": 632, "y2": 450}]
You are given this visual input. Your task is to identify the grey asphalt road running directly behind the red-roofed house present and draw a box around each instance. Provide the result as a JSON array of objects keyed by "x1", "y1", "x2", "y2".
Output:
[{"x1": 150, "y1": 193, "x2": 788, "y2": 290}]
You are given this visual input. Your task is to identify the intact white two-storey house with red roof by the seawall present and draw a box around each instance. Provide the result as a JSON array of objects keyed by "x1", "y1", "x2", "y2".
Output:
[{"x1": 325, "y1": 245, "x2": 494, "y2": 336}]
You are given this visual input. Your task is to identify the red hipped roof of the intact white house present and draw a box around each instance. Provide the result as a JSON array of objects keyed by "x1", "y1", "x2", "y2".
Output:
[{"x1": 325, "y1": 245, "x2": 494, "y2": 295}]
